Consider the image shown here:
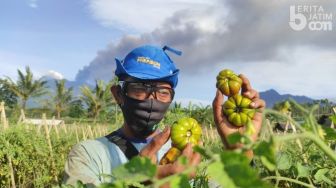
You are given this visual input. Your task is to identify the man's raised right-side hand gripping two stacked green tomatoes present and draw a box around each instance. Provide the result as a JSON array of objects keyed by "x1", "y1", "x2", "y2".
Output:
[{"x1": 212, "y1": 74, "x2": 265, "y2": 148}]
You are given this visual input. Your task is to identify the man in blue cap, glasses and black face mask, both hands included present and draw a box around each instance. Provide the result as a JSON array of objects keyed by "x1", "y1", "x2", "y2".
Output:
[{"x1": 64, "y1": 46, "x2": 265, "y2": 186}]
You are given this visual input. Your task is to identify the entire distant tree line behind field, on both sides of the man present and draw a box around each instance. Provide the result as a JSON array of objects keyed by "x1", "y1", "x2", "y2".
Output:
[{"x1": 0, "y1": 67, "x2": 335, "y2": 125}]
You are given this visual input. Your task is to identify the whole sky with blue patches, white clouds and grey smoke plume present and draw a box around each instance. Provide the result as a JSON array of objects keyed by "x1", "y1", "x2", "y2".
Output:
[{"x1": 0, "y1": 0, "x2": 336, "y2": 104}]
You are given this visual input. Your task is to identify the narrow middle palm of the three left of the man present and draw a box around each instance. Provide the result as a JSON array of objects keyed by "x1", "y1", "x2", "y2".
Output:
[{"x1": 54, "y1": 79, "x2": 73, "y2": 119}]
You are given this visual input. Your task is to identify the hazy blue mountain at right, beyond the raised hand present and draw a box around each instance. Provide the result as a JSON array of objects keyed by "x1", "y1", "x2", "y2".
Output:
[{"x1": 259, "y1": 89, "x2": 315, "y2": 108}]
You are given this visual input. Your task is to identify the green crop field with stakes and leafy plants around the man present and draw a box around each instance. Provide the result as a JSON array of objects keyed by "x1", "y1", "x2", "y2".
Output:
[{"x1": 0, "y1": 100, "x2": 336, "y2": 187}]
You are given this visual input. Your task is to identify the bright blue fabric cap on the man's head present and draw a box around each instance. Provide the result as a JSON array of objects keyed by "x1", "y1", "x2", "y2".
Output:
[{"x1": 115, "y1": 45, "x2": 182, "y2": 88}]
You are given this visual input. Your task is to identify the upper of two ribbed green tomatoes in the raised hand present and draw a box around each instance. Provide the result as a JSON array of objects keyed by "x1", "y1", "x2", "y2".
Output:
[{"x1": 216, "y1": 69, "x2": 243, "y2": 96}]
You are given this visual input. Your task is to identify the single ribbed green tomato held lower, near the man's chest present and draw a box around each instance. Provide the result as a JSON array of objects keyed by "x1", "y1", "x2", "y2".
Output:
[{"x1": 170, "y1": 117, "x2": 202, "y2": 150}]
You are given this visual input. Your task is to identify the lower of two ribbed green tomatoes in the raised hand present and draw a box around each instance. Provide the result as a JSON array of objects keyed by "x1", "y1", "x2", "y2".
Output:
[{"x1": 223, "y1": 95, "x2": 255, "y2": 127}]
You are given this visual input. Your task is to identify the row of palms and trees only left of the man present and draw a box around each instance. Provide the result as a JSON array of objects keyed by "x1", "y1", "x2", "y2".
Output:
[{"x1": 0, "y1": 66, "x2": 117, "y2": 123}]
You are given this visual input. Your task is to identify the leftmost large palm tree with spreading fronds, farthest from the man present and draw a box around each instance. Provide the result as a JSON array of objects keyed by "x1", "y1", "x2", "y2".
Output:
[{"x1": 3, "y1": 66, "x2": 47, "y2": 109}]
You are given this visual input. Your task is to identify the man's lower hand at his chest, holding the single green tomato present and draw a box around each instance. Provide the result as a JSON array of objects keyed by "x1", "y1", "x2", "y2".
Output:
[{"x1": 139, "y1": 128, "x2": 201, "y2": 179}]
